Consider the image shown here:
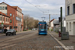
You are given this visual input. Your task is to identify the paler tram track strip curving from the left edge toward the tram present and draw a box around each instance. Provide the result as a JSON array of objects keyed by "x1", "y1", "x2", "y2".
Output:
[{"x1": 0, "y1": 32, "x2": 35, "y2": 48}]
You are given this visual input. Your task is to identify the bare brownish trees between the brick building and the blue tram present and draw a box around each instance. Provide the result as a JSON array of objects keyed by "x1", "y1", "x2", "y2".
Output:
[{"x1": 24, "y1": 15, "x2": 39, "y2": 30}]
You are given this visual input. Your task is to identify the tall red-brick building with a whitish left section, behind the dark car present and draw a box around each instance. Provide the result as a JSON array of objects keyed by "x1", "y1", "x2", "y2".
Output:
[{"x1": 0, "y1": 2, "x2": 23, "y2": 31}]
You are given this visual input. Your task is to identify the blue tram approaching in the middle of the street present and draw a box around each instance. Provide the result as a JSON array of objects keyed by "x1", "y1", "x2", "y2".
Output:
[{"x1": 38, "y1": 21, "x2": 47, "y2": 35}]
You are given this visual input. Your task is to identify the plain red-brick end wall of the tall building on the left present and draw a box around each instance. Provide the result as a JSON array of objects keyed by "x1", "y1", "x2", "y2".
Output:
[{"x1": 7, "y1": 5, "x2": 17, "y2": 28}]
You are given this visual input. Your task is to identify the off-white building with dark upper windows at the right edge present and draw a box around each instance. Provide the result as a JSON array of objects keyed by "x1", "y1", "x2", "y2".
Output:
[{"x1": 65, "y1": 0, "x2": 75, "y2": 35}]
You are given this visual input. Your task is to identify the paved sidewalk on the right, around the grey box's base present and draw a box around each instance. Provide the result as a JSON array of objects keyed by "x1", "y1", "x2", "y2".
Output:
[{"x1": 50, "y1": 32, "x2": 75, "y2": 50}]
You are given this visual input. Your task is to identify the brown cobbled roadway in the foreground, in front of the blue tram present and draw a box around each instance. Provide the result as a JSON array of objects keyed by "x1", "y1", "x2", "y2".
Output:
[{"x1": 0, "y1": 31, "x2": 62, "y2": 50}]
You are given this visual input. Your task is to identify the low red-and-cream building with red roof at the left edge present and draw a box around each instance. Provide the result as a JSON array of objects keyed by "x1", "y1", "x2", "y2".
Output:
[{"x1": 0, "y1": 12, "x2": 10, "y2": 29}]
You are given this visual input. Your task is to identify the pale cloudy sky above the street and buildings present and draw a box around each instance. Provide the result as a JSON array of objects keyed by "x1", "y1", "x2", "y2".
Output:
[{"x1": 0, "y1": 0, "x2": 65, "y2": 21}]
